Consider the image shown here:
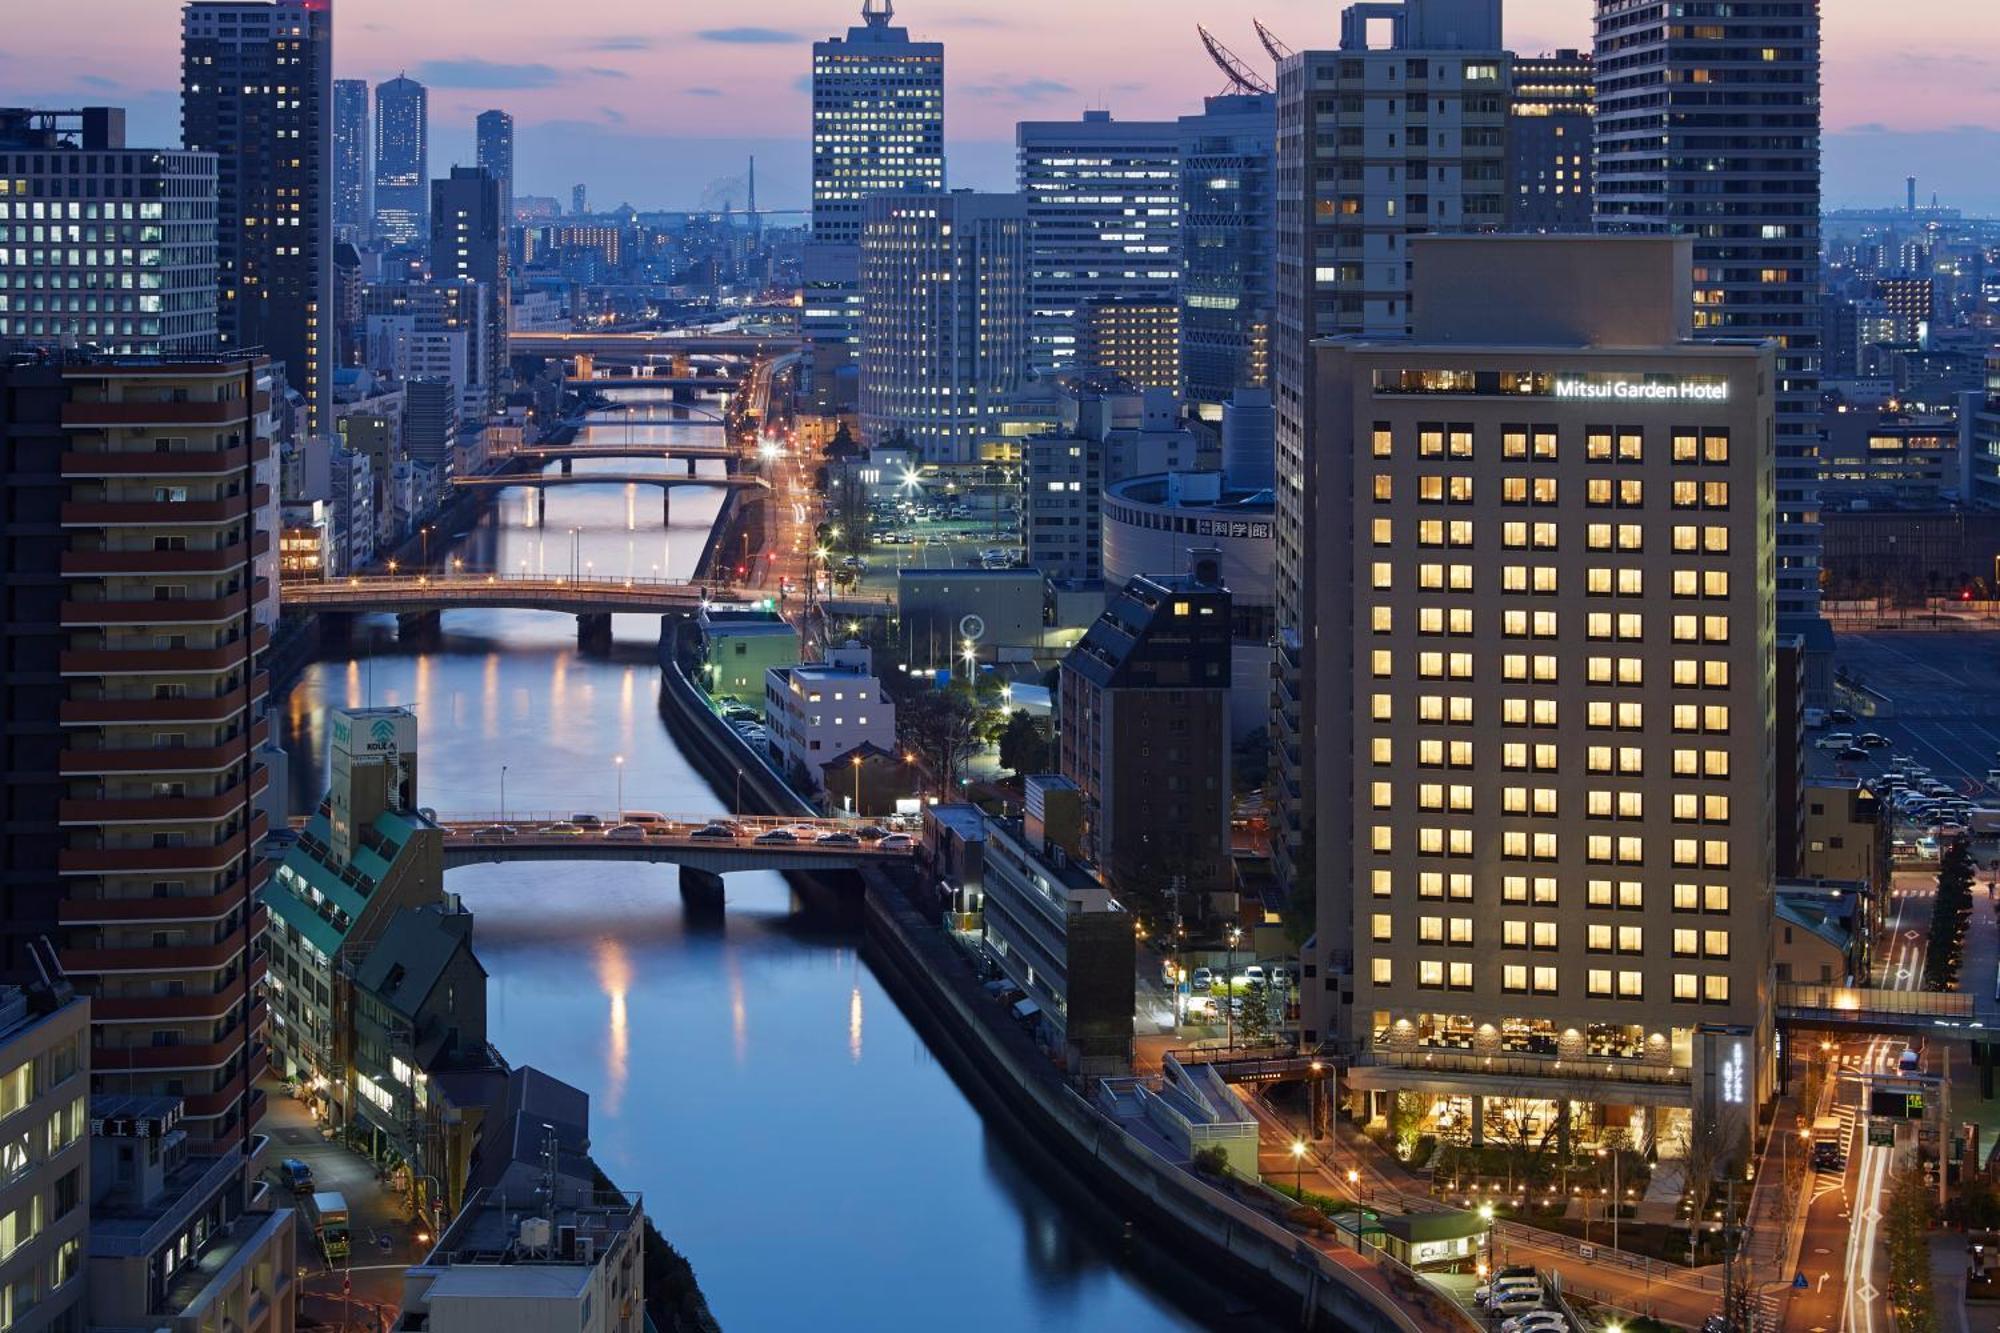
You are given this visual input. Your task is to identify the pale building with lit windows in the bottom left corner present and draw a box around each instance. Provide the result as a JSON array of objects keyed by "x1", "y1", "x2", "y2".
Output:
[{"x1": 0, "y1": 983, "x2": 90, "y2": 1333}]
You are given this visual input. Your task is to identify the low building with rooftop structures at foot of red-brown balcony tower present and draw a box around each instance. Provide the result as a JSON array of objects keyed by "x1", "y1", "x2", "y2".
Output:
[{"x1": 88, "y1": 1095, "x2": 300, "y2": 1333}]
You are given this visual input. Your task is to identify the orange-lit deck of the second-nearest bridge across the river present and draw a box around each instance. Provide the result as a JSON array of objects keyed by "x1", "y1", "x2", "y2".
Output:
[{"x1": 290, "y1": 574, "x2": 728, "y2": 616}]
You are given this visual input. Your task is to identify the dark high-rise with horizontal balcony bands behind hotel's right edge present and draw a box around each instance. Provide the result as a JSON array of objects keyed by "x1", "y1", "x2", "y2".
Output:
[{"x1": 1596, "y1": 0, "x2": 1832, "y2": 624}]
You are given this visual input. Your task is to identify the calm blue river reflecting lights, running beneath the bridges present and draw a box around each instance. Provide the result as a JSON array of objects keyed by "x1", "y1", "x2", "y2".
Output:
[{"x1": 282, "y1": 410, "x2": 1266, "y2": 1333}]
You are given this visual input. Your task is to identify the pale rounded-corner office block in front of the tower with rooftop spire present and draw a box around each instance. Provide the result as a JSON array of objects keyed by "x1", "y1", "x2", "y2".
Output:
[{"x1": 858, "y1": 192, "x2": 1028, "y2": 462}]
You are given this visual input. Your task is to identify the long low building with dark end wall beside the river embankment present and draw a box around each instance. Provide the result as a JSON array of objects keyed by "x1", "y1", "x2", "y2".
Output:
[{"x1": 980, "y1": 775, "x2": 1138, "y2": 1075}]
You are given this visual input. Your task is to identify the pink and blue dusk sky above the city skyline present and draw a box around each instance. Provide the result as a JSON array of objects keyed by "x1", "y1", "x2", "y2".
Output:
[{"x1": 15, "y1": 0, "x2": 2000, "y2": 212}]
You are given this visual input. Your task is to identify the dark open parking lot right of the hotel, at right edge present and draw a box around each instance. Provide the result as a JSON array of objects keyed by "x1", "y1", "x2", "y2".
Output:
[{"x1": 1806, "y1": 632, "x2": 2000, "y2": 805}]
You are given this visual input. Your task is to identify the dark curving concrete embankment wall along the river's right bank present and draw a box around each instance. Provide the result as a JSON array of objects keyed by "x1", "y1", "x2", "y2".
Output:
[{"x1": 660, "y1": 632, "x2": 1442, "y2": 1333}]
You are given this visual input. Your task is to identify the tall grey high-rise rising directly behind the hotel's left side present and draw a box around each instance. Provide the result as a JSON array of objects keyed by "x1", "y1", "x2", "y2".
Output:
[{"x1": 1270, "y1": 0, "x2": 1508, "y2": 895}]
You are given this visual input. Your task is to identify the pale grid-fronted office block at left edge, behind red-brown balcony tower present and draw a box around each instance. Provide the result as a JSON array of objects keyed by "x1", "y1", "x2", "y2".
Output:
[{"x1": 0, "y1": 106, "x2": 216, "y2": 352}]
